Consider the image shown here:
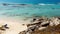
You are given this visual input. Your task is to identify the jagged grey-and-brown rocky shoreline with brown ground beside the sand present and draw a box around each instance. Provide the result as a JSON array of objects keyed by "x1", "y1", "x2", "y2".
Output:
[{"x1": 19, "y1": 17, "x2": 60, "y2": 34}]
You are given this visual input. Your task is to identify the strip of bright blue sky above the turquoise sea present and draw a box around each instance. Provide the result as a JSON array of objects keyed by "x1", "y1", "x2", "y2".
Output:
[{"x1": 0, "y1": 0, "x2": 60, "y2": 4}]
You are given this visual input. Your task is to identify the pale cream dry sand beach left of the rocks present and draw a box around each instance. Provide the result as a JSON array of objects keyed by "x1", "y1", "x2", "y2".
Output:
[{"x1": 0, "y1": 18, "x2": 29, "y2": 34}]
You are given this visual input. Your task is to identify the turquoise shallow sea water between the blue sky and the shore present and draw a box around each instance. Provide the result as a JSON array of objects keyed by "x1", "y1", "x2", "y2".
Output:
[{"x1": 0, "y1": 4, "x2": 60, "y2": 17}]
